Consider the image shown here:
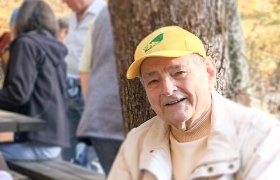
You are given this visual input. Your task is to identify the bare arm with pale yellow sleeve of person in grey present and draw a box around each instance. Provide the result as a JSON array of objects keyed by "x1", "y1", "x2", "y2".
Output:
[{"x1": 79, "y1": 24, "x2": 94, "y2": 101}]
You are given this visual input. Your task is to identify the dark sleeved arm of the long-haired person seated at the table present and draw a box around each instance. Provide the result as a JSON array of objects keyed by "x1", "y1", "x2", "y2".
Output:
[{"x1": 0, "y1": 39, "x2": 37, "y2": 110}]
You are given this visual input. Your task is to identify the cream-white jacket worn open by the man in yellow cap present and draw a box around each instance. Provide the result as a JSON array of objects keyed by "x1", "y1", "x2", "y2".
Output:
[{"x1": 108, "y1": 92, "x2": 280, "y2": 180}]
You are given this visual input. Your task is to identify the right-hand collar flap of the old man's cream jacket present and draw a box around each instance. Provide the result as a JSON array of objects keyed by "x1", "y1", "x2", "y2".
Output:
[{"x1": 201, "y1": 91, "x2": 239, "y2": 163}]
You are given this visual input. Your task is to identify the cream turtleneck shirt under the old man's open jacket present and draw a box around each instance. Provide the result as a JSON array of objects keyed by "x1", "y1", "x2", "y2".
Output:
[{"x1": 169, "y1": 112, "x2": 211, "y2": 180}]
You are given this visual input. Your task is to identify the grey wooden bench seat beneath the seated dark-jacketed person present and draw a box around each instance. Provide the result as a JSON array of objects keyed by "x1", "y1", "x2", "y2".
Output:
[{"x1": 7, "y1": 160, "x2": 105, "y2": 180}]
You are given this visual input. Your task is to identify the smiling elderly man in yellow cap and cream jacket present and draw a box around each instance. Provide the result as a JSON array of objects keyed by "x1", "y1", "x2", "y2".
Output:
[{"x1": 108, "y1": 26, "x2": 280, "y2": 180}]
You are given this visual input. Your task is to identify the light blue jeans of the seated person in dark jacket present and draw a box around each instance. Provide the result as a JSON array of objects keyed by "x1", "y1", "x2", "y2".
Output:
[{"x1": 0, "y1": 142, "x2": 61, "y2": 161}]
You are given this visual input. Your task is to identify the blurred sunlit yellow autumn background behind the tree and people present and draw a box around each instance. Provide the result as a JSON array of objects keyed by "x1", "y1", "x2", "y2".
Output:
[{"x1": 0, "y1": 0, "x2": 280, "y2": 118}]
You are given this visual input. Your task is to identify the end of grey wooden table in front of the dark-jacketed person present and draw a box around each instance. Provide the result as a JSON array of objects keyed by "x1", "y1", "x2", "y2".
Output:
[{"x1": 0, "y1": 110, "x2": 46, "y2": 143}]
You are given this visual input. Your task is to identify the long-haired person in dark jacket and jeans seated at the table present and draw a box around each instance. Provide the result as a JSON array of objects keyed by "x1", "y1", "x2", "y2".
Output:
[{"x1": 0, "y1": 1, "x2": 69, "y2": 160}]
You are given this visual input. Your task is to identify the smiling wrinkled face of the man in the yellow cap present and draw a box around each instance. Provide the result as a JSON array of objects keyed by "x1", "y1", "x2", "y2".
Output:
[{"x1": 141, "y1": 54, "x2": 215, "y2": 130}]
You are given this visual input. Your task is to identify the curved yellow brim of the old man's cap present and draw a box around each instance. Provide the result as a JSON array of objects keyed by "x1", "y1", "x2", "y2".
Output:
[{"x1": 126, "y1": 50, "x2": 194, "y2": 79}]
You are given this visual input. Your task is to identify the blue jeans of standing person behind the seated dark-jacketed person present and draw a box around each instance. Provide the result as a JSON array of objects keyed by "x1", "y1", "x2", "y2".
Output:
[{"x1": 62, "y1": 78, "x2": 87, "y2": 166}]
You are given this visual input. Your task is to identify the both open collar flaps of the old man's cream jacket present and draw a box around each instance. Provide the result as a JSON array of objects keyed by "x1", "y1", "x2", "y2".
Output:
[{"x1": 140, "y1": 91, "x2": 240, "y2": 180}]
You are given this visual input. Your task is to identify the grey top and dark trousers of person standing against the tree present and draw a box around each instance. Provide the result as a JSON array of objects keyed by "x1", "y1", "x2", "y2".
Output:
[{"x1": 77, "y1": 6, "x2": 124, "y2": 174}]
